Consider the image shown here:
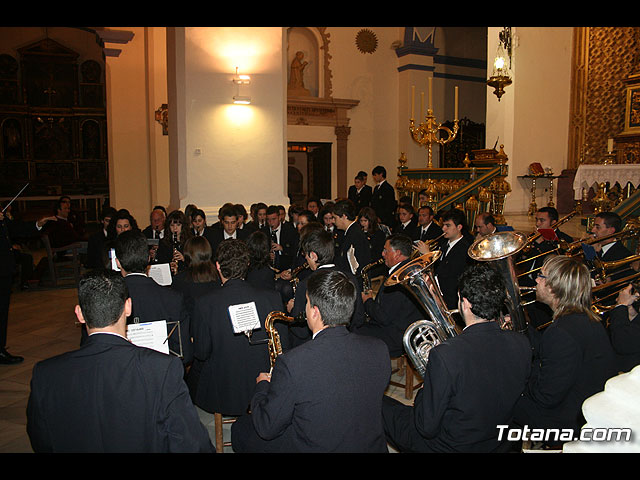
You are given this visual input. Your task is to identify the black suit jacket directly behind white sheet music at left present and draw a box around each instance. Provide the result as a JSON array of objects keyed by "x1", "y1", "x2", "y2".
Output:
[{"x1": 124, "y1": 274, "x2": 193, "y2": 365}]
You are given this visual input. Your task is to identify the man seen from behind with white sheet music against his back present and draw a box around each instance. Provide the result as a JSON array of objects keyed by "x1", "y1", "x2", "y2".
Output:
[{"x1": 193, "y1": 239, "x2": 289, "y2": 415}]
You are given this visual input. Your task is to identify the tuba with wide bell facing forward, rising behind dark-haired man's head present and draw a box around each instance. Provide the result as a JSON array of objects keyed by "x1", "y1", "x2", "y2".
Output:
[{"x1": 467, "y1": 231, "x2": 535, "y2": 333}]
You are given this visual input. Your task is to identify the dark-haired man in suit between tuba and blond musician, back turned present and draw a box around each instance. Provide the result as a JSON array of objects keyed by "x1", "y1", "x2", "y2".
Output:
[{"x1": 382, "y1": 263, "x2": 531, "y2": 453}]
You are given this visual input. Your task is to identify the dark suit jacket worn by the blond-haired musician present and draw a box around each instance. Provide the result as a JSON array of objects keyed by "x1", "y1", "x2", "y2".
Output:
[{"x1": 514, "y1": 314, "x2": 617, "y2": 430}]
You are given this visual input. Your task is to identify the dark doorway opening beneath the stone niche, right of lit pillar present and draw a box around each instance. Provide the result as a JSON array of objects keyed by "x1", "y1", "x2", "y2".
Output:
[{"x1": 287, "y1": 142, "x2": 331, "y2": 206}]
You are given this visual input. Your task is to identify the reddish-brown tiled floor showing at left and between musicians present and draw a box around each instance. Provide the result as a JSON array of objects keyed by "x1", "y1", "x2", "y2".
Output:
[{"x1": 0, "y1": 216, "x2": 585, "y2": 453}]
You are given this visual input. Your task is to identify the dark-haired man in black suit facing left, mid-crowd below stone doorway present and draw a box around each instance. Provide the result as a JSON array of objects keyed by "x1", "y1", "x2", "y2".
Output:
[{"x1": 333, "y1": 200, "x2": 371, "y2": 277}]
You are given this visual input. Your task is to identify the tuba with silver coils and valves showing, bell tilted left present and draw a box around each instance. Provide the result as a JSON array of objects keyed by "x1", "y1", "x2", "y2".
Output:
[{"x1": 385, "y1": 250, "x2": 458, "y2": 376}]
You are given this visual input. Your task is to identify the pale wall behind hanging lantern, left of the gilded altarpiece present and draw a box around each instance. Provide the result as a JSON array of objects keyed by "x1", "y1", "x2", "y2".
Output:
[{"x1": 487, "y1": 27, "x2": 573, "y2": 214}]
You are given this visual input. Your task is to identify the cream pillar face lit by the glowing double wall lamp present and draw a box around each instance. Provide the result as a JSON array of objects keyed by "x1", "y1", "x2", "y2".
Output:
[{"x1": 171, "y1": 27, "x2": 288, "y2": 218}]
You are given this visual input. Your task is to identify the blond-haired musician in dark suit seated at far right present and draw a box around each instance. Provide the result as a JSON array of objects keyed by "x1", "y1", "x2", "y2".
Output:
[{"x1": 514, "y1": 255, "x2": 617, "y2": 446}]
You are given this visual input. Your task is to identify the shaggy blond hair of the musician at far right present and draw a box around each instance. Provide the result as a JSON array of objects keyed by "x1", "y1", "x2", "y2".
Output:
[{"x1": 542, "y1": 255, "x2": 600, "y2": 322}]
